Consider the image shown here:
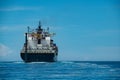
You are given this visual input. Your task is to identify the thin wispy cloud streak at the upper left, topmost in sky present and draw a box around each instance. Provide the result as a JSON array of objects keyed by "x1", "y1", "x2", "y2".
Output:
[{"x1": 0, "y1": 6, "x2": 40, "y2": 11}]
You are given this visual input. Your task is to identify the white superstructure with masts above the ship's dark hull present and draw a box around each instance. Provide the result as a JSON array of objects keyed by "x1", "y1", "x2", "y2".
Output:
[{"x1": 22, "y1": 23, "x2": 57, "y2": 53}]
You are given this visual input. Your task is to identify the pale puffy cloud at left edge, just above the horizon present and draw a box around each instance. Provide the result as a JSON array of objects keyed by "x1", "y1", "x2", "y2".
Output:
[{"x1": 0, "y1": 43, "x2": 13, "y2": 57}]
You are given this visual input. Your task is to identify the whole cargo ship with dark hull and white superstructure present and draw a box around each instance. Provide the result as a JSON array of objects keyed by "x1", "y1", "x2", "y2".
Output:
[{"x1": 20, "y1": 22, "x2": 58, "y2": 62}]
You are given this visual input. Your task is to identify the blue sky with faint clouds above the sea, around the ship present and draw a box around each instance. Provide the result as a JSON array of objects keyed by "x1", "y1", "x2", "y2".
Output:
[{"x1": 0, "y1": 0, "x2": 120, "y2": 61}]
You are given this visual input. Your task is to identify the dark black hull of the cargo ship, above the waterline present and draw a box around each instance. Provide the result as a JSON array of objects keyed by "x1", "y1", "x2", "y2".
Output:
[{"x1": 21, "y1": 53, "x2": 57, "y2": 62}]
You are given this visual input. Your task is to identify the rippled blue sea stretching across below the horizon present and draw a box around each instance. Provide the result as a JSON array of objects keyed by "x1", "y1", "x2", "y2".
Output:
[{"x1": 0, "y1": 61, "x2": 120, "y2": 80}]
